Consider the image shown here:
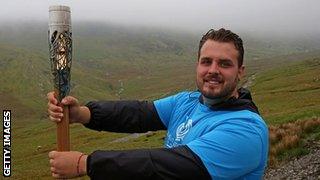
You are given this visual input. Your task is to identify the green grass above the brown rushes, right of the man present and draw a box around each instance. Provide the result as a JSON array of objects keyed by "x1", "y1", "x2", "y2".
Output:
[{"x1": 251, "y1": 57, "x2": 320, "y2": 124}]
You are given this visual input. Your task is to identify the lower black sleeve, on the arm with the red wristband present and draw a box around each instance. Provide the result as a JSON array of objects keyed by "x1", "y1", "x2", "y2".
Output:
[{"x1": 87, "y1": 145, "x2": 211, "y2": 180}]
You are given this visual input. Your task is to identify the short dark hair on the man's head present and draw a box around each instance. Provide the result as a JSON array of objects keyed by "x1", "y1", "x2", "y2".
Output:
[{"x1": 198, "y1": 28, "x2": 244, "y2": 67}]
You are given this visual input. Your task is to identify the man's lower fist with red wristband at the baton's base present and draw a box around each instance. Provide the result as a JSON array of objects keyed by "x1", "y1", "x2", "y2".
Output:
[{"x1": 49, "y1": 151, "x2": 88, "y2": 179}]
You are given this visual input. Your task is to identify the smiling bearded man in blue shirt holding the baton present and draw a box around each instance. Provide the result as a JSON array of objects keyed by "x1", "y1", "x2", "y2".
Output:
[{"x1": 48, "y1": 29, "x2": 268, "y2": 180}]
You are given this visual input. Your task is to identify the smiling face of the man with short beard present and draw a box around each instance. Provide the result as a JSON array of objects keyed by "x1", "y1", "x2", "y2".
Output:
[{"x1": 197, "y1": 40, "x2": 244, "y2": 99}]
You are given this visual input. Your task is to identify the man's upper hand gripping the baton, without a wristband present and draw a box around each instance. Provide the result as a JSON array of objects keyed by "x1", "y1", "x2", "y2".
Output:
[{"x1": 47, "y1": 92, "x2": 90, "y2": 124}]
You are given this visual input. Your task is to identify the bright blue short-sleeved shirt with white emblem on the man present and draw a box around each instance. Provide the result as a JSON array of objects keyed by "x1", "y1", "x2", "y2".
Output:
[{"x1": 154, "y1": 92, "x2": 268, "y2": 180}]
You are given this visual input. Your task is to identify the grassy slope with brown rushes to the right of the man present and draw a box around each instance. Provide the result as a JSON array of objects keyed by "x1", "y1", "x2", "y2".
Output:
[{"x1": 251, "y1": 56, "x2": 320, "y2": 167}]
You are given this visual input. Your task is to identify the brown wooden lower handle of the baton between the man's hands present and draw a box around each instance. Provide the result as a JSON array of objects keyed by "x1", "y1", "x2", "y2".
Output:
[{"x1": 57, "y1": 105, "x2": 70, "y2": 151}]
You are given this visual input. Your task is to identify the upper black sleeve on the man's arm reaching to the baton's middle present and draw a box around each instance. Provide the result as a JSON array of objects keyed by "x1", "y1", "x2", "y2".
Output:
[{"x1": 84, "y1": 101, "x2": 166, "y2": 133}]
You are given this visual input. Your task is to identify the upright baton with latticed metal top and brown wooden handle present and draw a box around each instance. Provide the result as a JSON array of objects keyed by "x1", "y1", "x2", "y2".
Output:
[{"x1": 48, "y1": 6, "x2": 72, "y2": 151}]
